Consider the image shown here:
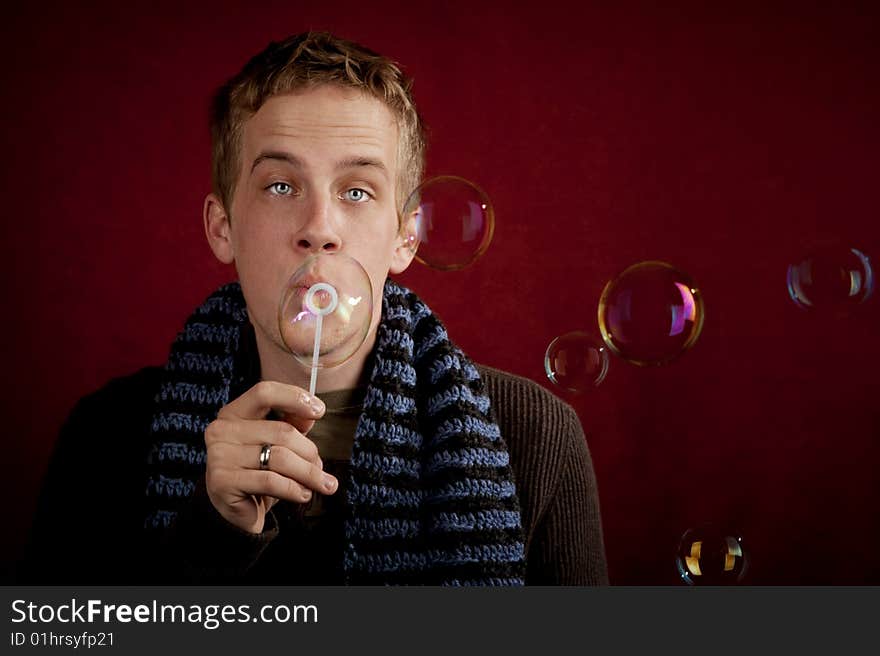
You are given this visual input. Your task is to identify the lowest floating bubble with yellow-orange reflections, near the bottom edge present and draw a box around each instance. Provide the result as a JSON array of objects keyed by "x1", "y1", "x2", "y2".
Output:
[{"x1": 675, "y1": 523, "x2": 749, "y2": 585}]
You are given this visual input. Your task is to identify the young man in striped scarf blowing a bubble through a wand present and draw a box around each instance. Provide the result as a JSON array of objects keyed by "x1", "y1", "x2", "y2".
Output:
[{"x1": 20, "y1": 33, "x2": 607, "y2": 585}]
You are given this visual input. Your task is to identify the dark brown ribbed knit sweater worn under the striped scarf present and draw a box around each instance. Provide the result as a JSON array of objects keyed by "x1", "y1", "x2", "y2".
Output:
[{"x1": 17, "y1": 366, "x2": 608, "y2": 585}]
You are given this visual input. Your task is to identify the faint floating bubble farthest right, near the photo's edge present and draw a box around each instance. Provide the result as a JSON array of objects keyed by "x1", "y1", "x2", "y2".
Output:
[{"x1": 786, "y1": 245, "x2": 874, "y2": 310}]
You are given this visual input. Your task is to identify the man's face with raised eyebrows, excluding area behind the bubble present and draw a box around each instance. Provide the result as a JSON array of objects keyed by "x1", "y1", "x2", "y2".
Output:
[{"x1": 215, "y1": 85, "x2": 412, "y2": 372}]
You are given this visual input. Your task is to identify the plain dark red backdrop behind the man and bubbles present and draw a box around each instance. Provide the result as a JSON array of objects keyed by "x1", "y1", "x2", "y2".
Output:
[{"x1": 0, "y1": 0, "x2": 880, "y2": 585}]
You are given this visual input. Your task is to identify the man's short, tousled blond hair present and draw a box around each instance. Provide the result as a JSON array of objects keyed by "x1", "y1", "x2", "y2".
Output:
[{"x1": 211, "y1": 32, "x2": 427, "y2": 216}]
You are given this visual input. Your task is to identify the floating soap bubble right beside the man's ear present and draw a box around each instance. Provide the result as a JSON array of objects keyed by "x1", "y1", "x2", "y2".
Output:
[{"x1": 403, "y1": 175, "x2": 495, "y2": 271}]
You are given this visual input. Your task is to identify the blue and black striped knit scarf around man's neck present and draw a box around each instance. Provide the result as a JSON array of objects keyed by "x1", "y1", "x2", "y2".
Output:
[{"x1": 145, "y1": 281, "x2": 524, "y2": 585}]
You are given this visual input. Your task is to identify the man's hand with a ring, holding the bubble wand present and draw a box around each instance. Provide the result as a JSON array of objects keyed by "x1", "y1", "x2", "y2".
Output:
[{"x1": 205, "y1": 381, "x2": 339, "y2": 533}]
